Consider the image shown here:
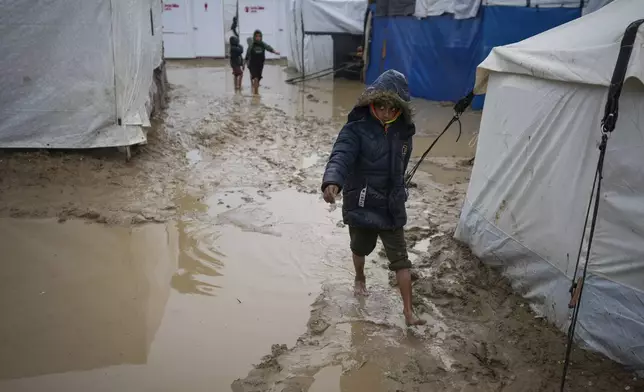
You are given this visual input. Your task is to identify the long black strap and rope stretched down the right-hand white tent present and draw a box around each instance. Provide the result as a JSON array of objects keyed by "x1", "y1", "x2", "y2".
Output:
[{"x1": 560, "y1": 19, "x2": 644, "y2": 392}]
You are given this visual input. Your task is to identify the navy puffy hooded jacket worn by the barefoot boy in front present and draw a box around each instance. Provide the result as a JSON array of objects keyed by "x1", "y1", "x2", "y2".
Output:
[{"x1": 322, "y1": 70, "x2": 416, "y2": 230}]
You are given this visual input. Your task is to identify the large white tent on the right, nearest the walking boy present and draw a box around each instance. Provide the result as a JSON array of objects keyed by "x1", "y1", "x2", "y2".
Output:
[{"x1": 456, "y1": 0, "x2": 644, "y2": 369}]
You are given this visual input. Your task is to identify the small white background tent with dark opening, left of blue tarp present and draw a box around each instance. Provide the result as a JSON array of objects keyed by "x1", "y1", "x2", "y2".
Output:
[{"x1": 287, "y1": 0, "x2": 367, "y2": 74}]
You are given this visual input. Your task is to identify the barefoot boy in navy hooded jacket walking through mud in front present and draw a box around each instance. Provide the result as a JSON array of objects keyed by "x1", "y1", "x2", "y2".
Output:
[{"x1": 322, "y1": 70, "x2": 425, "y2": 325}]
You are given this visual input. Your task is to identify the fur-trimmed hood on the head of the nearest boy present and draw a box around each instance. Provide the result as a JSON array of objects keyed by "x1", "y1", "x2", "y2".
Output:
[{"x1": 350, "y1": 69, "x2": 413, "y2": 124}]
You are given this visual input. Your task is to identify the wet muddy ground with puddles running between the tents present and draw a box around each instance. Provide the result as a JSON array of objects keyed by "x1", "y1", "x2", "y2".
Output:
[{"x1": 0, "y1": 62, "x2": 644, "y2": 392}]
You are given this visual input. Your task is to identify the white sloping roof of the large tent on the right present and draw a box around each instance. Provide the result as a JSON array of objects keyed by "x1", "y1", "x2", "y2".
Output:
[{"x1": 476, "y1": 0, "x2": 644, "y2": 93}]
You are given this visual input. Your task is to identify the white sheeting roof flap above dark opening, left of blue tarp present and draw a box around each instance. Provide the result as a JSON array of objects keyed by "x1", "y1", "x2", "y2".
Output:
[{"x1": 303, "y1": 0, "x2": 367, "y2": 35}]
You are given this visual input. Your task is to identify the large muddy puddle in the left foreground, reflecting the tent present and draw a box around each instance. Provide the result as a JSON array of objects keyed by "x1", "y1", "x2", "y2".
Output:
[{"x1": 0, "y1": 189, "x2": 348, "y2": 391}]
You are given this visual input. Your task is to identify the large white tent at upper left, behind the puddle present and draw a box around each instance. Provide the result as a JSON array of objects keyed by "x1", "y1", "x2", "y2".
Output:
[{"x1": 0, "y1": 0, "x2": 163, "y2": 148}]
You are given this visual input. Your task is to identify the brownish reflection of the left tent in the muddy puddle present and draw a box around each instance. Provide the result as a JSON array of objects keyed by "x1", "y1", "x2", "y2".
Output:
[{"x1": 0, "y1": 219, "x2": 177, "y2": 379}]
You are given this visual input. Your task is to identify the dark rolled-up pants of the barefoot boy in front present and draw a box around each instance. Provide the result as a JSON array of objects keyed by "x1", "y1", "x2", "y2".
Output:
[{"x1": 349, "y1": 227, "x2": 411, "y2": 271}]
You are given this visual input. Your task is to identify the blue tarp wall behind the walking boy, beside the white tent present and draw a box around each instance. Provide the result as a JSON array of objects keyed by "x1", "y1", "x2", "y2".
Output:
[{"x1": 366, "y1": 6, "x2": 581, "y2": 109}]
